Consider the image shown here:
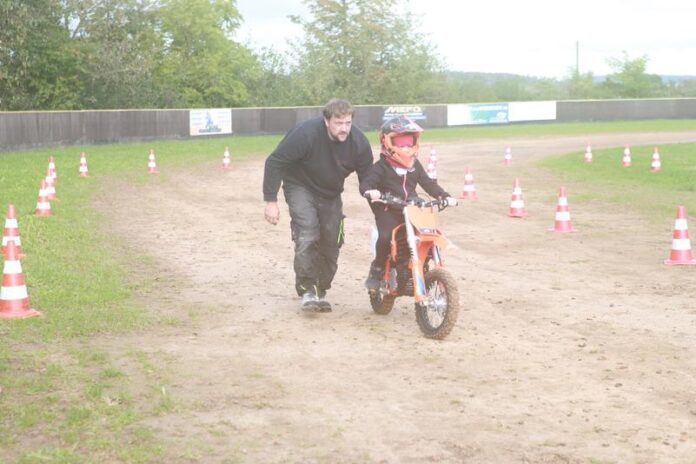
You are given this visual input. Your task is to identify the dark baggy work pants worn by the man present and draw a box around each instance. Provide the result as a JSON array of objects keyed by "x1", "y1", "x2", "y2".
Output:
[{"x1": 283, "y1": 183, "x2": 343, "y2": 296}]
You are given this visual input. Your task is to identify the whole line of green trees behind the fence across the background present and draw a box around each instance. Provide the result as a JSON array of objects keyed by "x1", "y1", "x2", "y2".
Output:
[{"x1": 0, "y1": 0, "x2": 696, "y2": 111}]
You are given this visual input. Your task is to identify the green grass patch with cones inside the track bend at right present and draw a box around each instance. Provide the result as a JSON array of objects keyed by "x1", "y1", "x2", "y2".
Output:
[{"x1": 539, "y1": 144, "x2": 696, "y2": 224}]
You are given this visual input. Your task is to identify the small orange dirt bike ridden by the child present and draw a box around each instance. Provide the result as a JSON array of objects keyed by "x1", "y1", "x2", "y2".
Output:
[{"x1": 369, "y1": 194, "x2": 459, "y2": 340}]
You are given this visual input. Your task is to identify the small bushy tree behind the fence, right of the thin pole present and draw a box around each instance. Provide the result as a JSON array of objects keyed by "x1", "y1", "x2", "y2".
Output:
[{"x1": 604, "y1": 51, "x2": 662, "y2": 98}]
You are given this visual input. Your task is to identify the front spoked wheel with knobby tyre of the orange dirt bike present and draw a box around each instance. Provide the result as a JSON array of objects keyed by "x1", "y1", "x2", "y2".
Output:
[{"x1": 416, "y1": 269, "x2": 459, "y2": 340}]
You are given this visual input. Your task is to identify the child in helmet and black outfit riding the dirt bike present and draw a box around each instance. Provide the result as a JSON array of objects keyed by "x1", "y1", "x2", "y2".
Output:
[{"x1": 360, "y1": 117, "x2": 457, "y2": 292}]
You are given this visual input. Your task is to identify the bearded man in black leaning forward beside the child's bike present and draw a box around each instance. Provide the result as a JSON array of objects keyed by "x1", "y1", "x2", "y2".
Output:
[{"x1": 263, "y1": 99, "x2": 372, "y2": 312}]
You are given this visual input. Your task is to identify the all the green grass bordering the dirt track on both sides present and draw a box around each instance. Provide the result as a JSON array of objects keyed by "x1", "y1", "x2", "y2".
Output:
[{"x1": 0, "y1": 120, "x2": 696, "y2": 463}]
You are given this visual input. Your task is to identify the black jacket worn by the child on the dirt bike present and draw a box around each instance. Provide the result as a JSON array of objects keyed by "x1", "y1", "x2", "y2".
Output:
[{"x1": 360, "y1": 156, "x2": 451, "y2": 204}]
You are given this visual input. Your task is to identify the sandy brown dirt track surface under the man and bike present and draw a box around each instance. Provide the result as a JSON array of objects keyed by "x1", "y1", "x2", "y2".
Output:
[{"x1": 96, "y1": 132, "x2": 696, "y2": 463}]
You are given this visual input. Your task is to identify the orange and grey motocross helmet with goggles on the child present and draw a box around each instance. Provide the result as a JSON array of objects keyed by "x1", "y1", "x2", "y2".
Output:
[{"x1": 379, "y1": 116, "x2": 423, "y2": 169}]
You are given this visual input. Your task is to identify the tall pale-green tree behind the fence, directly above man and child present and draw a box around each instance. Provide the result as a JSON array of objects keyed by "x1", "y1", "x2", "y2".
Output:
[{"x1": 291, "y1": 0, "x2": 444, "y2": 105}]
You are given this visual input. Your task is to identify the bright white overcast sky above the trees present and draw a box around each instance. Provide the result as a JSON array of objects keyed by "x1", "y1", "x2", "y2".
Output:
[{"x1": 236, "y1": 0, "x2": 696, "y2": 79}]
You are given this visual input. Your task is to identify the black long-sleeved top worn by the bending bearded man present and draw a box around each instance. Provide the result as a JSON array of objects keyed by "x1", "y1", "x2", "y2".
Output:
[{"x1": 263, "y1": 117, "x2": 373, "y2": 201}]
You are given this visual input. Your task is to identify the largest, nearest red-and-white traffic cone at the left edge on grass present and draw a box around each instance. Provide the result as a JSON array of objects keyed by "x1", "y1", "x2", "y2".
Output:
[{"x1": 0, "y1": 240, "x2": 41, "y2": 319}]
